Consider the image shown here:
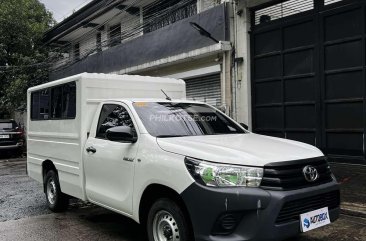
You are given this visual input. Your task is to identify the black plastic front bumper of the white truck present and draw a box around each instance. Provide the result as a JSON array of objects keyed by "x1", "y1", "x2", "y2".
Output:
[{"x1": 182, "y1": 181, "x2": 339, "y2": 241}]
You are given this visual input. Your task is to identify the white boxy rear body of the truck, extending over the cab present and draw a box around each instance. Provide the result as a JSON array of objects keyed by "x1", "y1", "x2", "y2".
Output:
[{"x1": 27, "y1": 73, "x2": 186, "y2": 200}]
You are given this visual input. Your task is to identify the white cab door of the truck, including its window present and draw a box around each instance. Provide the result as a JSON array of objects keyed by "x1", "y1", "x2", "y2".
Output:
[{"x1": 84, "y1": 104, "x2": 139, "y2": 214}]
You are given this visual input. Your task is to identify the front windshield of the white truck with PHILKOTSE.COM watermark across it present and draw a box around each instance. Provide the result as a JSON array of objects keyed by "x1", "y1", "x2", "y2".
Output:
[{"x1": 133, "y1": 102, "x2": 246, "y2": 137}]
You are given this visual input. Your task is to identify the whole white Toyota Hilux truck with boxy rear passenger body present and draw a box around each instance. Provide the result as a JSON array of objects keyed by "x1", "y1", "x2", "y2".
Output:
[{"x1": 27, "y1": 73, "x2": 340, "y2": 241}]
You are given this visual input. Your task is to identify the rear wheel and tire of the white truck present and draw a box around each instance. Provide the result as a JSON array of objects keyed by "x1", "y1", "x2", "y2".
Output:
[{"x1": 44, "y1": 170, "x2": 69, "y2": 212}]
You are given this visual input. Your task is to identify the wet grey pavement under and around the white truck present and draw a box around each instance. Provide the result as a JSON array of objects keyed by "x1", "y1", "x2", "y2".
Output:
[{"x1": 0, "y1": 159, "x2": 366, "y2": 241}]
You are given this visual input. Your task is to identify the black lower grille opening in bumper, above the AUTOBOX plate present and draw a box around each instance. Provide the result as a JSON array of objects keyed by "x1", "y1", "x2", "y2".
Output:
[{"x1": 276, "y1": 191, "x2": 340, "y2": 224}]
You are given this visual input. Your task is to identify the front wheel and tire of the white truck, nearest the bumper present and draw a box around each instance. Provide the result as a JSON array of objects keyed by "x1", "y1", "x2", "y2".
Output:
[{"x1": 146, "y1": 198, "x2": 194, "y2": 241}]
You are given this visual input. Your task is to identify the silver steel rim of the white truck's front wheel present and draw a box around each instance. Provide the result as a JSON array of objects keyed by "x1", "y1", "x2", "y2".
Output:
[{"x1": 153, "y1": 211, "x2": 180, "y2": 241}]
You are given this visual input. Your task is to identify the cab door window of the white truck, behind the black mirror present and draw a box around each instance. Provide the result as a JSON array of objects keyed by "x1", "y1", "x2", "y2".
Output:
[{"x1": 96, "y1": 104, "x2": 136, "y2": 139}]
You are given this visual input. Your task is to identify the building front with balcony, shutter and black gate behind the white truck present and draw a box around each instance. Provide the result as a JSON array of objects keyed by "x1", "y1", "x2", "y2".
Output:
[{"x1": 44, "y1": 0, "x2": 366, "y2": 164}]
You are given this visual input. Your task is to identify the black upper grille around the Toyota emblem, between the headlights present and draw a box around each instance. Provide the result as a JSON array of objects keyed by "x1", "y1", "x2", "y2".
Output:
[{"x1": 261, "y1": 157, "x2": 332, "y2": 191}]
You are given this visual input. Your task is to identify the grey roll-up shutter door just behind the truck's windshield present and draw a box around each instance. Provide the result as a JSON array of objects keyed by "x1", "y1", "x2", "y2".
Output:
[{"x1": 184, "y1": 73, "x2": 221, "y2": 107}]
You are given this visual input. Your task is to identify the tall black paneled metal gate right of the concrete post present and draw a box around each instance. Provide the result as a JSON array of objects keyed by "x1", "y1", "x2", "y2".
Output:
[{"x1": 251, "y1": 0, "x2": 366, "y2": 164}]
